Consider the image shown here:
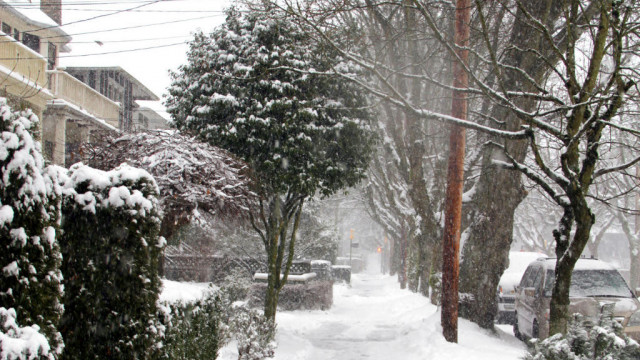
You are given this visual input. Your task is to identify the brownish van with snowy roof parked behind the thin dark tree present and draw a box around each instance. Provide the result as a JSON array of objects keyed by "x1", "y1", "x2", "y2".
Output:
[{"x1": 513, "y1": 259, "x2": 640, "y2": 341}]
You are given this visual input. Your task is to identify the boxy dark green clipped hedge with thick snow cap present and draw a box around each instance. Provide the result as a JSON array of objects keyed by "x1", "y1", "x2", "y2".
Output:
[{"x1": 60, "y1": 164, "x2": 164, "y2": 360}]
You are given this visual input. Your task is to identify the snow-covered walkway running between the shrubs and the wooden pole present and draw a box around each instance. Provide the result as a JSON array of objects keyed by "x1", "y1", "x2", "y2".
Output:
[{"x1": 221, "y1": 268, "x2": 526, "y2": 360}]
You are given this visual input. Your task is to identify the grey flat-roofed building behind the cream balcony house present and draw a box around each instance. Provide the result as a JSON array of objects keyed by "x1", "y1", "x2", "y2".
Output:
[{"x1": 65, "y1": 66, "x2": 166, "y2": 131}]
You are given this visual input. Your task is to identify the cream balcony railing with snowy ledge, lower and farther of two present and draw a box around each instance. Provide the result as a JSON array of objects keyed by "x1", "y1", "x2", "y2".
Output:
[{"x1": 47, "y1": 70, "x2": 120, "y2": 128}]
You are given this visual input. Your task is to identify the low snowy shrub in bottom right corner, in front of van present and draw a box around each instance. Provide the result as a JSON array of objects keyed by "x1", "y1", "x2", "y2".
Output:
[{"x1": 525, "y1": 312, "x2": 640, "y2": 360}]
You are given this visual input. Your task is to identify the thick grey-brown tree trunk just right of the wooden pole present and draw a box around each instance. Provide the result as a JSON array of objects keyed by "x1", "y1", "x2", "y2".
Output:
[{"x1": 460, "y1": 0, "x2": 561, "y2": 329}]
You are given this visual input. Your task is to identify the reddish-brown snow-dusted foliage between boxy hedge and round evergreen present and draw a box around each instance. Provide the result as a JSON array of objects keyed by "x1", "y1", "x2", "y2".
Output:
[{"x1": 84, "y1": 130, "x2": 255, "y2": 238}]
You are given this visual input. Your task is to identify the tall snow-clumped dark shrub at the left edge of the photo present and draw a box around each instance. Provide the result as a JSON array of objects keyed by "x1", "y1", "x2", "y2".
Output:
[{"x1": 0, "y1": 98, "x2": 63, "y2": 356}]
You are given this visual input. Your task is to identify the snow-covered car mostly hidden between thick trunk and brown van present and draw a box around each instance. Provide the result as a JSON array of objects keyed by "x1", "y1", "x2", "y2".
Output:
[{"x1": 496, "y1": 251, "x2": 545, "y2": 324}]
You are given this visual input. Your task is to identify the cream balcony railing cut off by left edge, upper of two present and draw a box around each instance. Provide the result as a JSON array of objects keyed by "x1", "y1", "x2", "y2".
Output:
[{"x1": 0, "y1": 32, "x2": 47, "y2": 88}]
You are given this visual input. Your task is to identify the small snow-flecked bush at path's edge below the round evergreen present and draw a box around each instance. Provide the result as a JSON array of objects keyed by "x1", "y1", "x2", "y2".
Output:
[{"x1": 230, "y1": 306, "x2": 276, "y2": 360}]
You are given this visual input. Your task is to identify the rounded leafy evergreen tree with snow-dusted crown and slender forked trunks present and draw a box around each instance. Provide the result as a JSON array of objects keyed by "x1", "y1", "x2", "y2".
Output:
[{"x1": 167, "y1": 9, "x2": 372, "y2": 319}]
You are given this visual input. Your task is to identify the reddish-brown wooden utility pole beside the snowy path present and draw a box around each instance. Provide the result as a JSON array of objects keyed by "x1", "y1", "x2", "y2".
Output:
[{"x1": 441, "y1": 0, "x2": 470, "y2": 343}]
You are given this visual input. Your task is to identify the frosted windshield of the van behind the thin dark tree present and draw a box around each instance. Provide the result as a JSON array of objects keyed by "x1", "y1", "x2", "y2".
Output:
[{"x1": 544, "y1": 270, "x2": 633, "y2": 298}]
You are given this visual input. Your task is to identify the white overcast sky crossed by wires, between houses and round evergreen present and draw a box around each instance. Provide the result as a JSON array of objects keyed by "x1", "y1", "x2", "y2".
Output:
[{"x1": 60, "y1": 0, "x2": 232, "y2": 100}]
